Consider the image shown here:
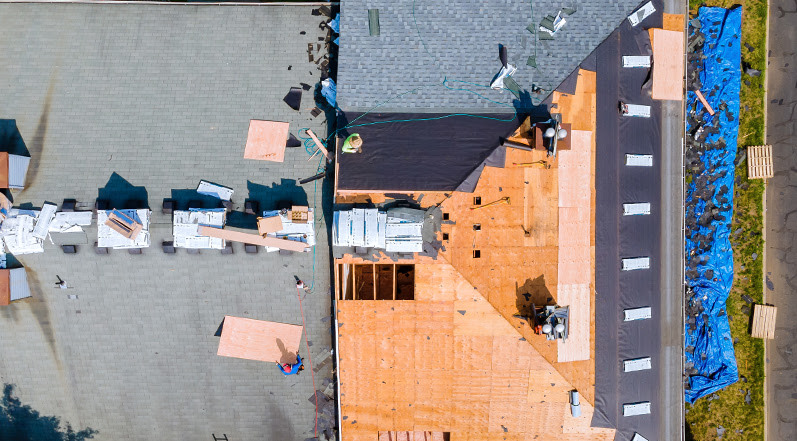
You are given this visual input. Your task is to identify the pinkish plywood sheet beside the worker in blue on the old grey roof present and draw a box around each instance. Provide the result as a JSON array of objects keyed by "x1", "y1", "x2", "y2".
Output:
[{"x1": 217, "y1": 315, "x2": 302, "y2": 363}]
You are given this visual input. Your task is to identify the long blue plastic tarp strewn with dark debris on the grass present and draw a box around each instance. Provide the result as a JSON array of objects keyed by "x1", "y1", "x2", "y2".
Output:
[{"x1": 685, "y1": 7, "x2": 742, "y2": 403}]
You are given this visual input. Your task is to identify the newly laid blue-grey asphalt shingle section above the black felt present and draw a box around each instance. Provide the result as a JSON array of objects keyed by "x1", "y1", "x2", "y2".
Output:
[{"x1": 337, "y1": 0, "x2": 640, "y2": 112}]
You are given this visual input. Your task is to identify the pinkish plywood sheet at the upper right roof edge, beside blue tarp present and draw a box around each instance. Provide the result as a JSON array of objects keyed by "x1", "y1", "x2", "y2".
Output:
[{"x1": 651, "y1": 29, "x2": 684, "y2": 101}]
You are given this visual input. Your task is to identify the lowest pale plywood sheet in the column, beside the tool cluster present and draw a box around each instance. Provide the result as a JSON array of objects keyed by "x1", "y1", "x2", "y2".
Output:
[{"x1": 557, "y1": 284, "x2": 592, "y2": 363}]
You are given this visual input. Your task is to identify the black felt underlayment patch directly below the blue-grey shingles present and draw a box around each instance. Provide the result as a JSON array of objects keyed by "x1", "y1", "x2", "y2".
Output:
[{"x1": 337, "y1": 113, "x2": 520, "y2": 191}]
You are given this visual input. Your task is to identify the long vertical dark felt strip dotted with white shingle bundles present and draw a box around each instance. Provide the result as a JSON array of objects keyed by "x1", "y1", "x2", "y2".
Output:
[{"x1": 593, "y1": 1, "x2": 662, "y2": 439}]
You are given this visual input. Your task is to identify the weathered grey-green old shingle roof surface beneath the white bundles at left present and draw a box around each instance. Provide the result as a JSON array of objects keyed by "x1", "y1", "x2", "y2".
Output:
[{"x1": 0, "y1": 4, "x2": 332, "y2": 440}]
